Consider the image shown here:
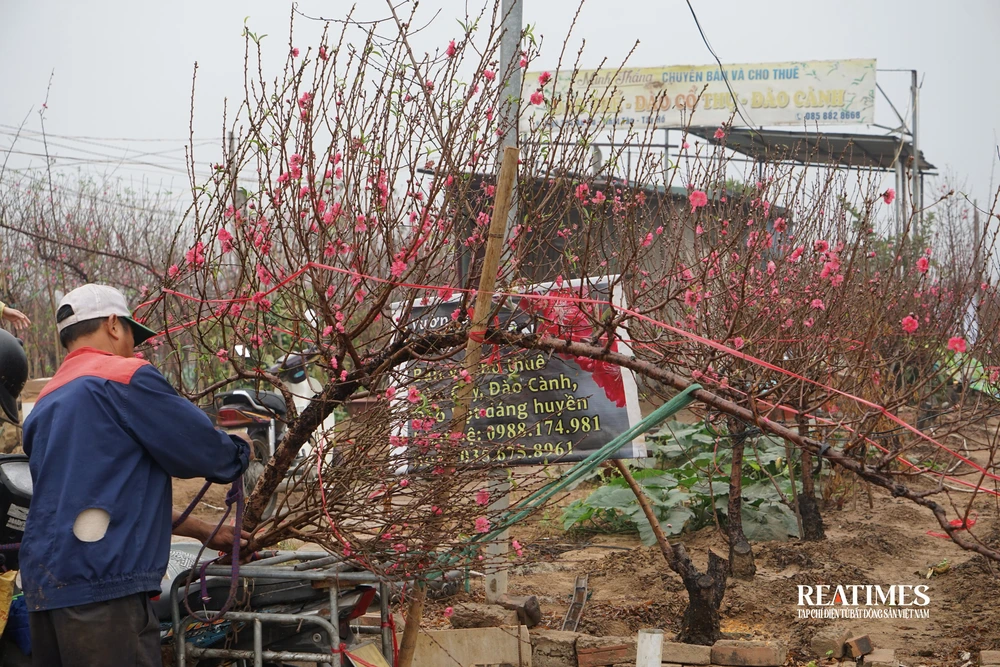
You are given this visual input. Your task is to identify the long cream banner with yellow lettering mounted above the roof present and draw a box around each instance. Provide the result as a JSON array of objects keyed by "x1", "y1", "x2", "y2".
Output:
[{"x1": 522, "y1": 59, "x2": 875, "y2": 130}]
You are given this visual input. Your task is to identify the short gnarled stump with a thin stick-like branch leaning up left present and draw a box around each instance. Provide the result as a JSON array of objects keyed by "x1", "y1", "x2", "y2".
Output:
[{"x1": 613, "y1": 460, "x2": 729, "y2": 646}]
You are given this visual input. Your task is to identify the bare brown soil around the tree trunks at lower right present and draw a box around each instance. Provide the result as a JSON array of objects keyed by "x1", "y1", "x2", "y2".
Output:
[{"x1": 408, "y1": 482, "x2": 1000, "y2": 667}]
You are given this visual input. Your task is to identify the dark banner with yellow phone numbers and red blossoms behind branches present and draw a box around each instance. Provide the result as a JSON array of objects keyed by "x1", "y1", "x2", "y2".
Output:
[{"x1": 393, "y1": 277, "x2": 646, "y2": 465}]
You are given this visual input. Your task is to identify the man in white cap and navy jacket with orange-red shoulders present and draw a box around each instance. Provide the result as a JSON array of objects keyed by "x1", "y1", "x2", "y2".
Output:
[{"x1": 20, "y1": 285, "x2": 249, "y2": 667}]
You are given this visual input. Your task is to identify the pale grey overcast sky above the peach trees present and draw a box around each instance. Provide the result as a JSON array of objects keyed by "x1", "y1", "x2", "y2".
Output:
[{"x1": 0, "y1": 0, "x2": 1000, "y2": 206}]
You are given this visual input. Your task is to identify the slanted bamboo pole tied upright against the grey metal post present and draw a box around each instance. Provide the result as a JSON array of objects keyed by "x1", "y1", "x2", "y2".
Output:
[{"x1": 398, "y1": 146, "x2": 519, "y2": 667}]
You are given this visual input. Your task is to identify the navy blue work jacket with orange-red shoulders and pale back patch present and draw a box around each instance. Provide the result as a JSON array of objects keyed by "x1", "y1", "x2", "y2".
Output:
[{"x1": 19, "y1": 347, "x2": 249, "y2": 611}]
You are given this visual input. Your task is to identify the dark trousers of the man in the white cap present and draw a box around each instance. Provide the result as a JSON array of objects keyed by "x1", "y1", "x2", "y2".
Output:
[{"x1": 28, "y1": 593, "x2": 163, "y2": 667}]
